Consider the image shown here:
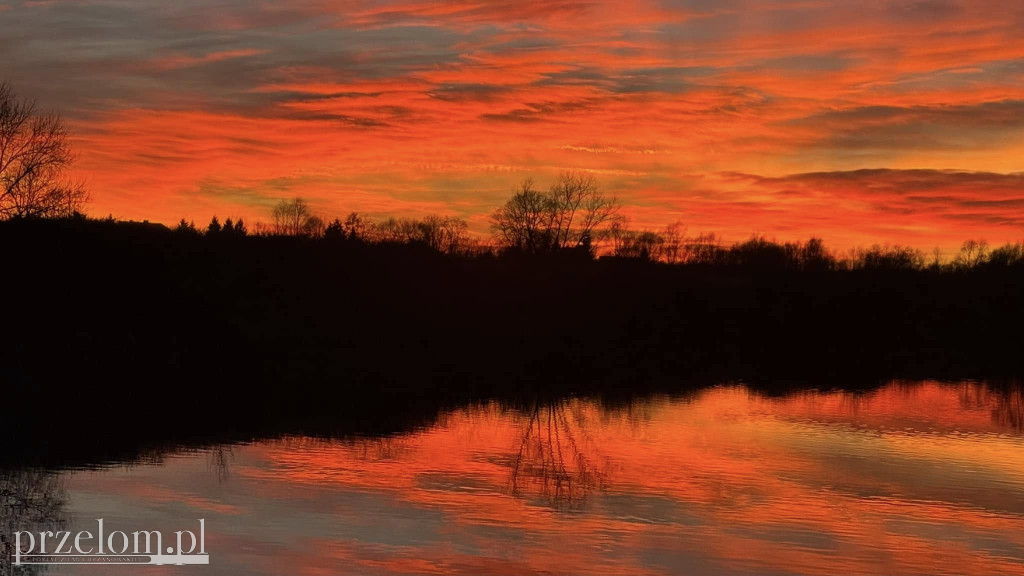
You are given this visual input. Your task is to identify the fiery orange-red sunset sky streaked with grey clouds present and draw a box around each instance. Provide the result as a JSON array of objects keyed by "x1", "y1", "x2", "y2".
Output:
[{"x1": 0, "y1": 0, "x2": 1024, "y2": 250}]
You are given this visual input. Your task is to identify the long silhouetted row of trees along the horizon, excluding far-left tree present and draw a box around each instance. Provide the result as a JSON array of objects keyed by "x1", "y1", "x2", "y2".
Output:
[{"x1": 175, "y1": 189, "x2": 1024, "y2": 272}]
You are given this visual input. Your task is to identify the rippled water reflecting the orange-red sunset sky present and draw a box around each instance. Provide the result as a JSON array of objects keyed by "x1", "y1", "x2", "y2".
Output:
[{"x1": 6, "y1": 382, "x2": 1024, "y2": 575}]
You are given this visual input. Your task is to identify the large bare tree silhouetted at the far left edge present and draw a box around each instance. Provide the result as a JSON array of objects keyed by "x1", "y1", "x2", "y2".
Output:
[{"x1": 0, "y1": 83, "x2": 89, "y2": 218}]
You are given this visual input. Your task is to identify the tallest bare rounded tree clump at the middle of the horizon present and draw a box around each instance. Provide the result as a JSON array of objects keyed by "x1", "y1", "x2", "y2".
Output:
[{"x1": 490, "y1": 172, "x2": 618, "y2": 252}]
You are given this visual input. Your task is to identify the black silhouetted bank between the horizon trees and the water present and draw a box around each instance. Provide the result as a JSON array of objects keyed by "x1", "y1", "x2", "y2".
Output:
[{"x1": 0, "y1": 217, "x2": 1024, "y2": 462}]
